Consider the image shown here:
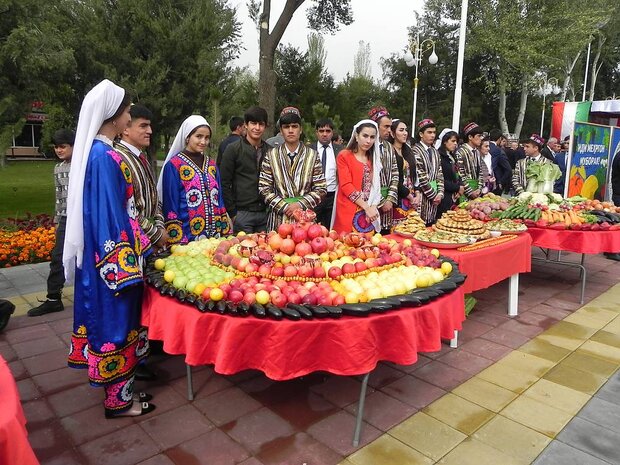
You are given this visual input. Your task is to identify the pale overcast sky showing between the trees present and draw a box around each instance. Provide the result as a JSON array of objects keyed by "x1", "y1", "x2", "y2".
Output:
[{"x1": 230, "y1": 0, "x2": 424, "y2": 81}]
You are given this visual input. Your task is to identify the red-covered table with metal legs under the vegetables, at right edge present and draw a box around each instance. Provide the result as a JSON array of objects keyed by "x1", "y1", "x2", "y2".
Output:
[{"x1": 528, "y1": 227, "x2": 620, "y2": 304}]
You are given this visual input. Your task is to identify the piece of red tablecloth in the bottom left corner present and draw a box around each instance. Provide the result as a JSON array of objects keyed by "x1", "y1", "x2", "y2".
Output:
[{"x1": 0, "y1": 356, "x2": 39, "y2": 465}]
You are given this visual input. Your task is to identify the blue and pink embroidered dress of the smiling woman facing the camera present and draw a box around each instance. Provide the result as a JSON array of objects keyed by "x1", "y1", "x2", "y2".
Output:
[{"x1": 162, "y1": 152, "x2": 231, "y2": 244}]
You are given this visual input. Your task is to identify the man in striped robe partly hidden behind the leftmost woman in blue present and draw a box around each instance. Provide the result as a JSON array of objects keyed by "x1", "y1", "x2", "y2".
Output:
[{"x1": 114, "y1": 105, "x2": 168, "y2": 250}]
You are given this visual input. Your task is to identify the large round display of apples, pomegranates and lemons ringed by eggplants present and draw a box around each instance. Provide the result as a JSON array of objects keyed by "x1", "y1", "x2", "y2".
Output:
[{"x1": 146, "y1": 217, "x2": 465, "y2": 320}]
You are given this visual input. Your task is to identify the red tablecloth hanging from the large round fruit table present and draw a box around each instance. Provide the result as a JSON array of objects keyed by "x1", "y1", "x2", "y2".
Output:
[{"x1": 142, "y1": 286, "x2": 465, "y2": 380}]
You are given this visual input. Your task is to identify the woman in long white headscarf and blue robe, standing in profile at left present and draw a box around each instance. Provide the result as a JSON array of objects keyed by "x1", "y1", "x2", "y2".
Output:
[{"x1": 63, "y1": 80, "x2": 155, "y2": 418}]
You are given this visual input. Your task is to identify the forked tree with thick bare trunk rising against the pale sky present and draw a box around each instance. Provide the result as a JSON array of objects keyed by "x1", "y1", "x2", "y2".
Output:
[{"x1": 248, "y1": 0, "x2": 353, "y2": 123}]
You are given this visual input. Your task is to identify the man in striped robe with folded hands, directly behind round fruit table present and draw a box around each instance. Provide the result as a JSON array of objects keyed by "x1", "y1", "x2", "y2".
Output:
[{"x1": 258, "y1": 107, "x2": 327, "y2": 231}]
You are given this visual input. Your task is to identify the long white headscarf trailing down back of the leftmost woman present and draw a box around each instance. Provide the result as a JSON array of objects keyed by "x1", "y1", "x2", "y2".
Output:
[{"x1": 62, "y1": 79, "x2": 125, "y2": 282}]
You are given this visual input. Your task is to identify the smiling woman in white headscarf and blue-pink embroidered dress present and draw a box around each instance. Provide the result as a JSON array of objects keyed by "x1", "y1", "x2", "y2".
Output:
[{"x1": 157, "y1": 115, "x2": 231, "y2": 244}]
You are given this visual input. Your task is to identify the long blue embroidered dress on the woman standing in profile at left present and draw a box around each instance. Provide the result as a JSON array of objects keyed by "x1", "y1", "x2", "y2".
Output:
[{"x1": 69, "y1": 140, "x2": 151, "y2": 413}]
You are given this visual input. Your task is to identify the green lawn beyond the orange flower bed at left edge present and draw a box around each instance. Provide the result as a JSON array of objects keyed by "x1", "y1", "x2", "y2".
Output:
[{"x1": 0, "y1": 160, "x2": 56, "y2": 219}]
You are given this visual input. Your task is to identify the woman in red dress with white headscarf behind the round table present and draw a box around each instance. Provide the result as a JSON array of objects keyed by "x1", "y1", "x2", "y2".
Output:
[{"x1": 332, "y1": 119, "x2": 382, "y2": 232}]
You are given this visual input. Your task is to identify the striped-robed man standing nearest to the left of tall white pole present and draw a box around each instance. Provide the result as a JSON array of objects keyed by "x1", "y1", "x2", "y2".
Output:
[{"x1": 412, "y1": 118, "x2": 444, "y2": 226}]
